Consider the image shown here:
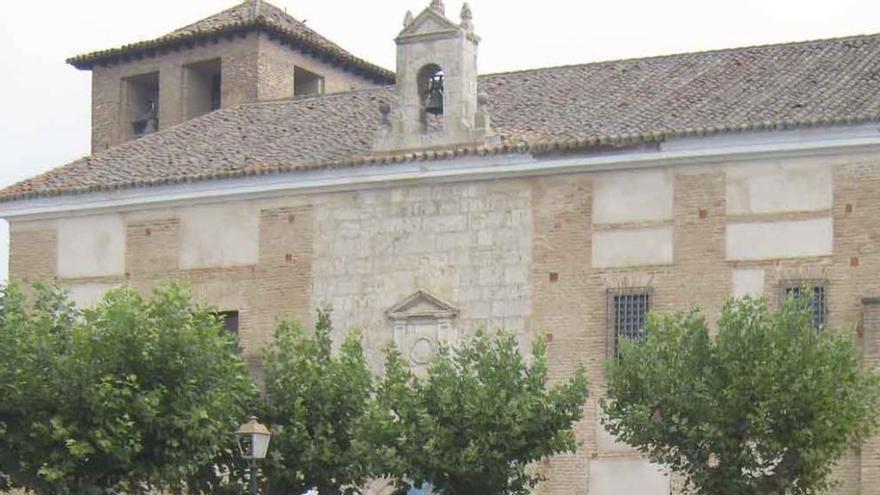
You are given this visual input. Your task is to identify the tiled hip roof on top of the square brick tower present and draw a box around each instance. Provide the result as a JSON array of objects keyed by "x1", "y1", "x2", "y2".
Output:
[{"x1": 67, "y1": 0, "x2": 394, "y2": 83}]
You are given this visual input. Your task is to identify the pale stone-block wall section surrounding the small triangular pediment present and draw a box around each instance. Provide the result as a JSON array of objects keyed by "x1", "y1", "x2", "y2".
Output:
[{"x1": 312, "y1": 181, "x2": 532, "y2": 369}]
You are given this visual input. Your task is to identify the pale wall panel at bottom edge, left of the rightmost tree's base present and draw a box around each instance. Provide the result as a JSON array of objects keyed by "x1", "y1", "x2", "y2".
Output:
[{"x1": 589, "y1": 459, "x2": 669, "y2": 495}]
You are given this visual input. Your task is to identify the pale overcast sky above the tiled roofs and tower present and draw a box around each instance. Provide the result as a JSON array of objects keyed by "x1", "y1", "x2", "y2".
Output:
[{"x1": 0, "y1": 0, "x2": 880, "y2": 279}]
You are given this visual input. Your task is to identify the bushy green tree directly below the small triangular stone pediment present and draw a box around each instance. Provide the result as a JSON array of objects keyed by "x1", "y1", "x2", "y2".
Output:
[{"x1": 368, "y1": 331, "x2": 587, "y2": 495}]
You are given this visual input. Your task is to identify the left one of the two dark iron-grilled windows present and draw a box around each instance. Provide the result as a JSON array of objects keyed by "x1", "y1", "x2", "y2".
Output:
[{"x1": 608, "y1": 289, "x2": 651, "y2": 357}]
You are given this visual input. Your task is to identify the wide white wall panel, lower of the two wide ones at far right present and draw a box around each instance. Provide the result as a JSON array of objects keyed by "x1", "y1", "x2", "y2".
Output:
[{"x1": 727, "y1": 218, "x2": 834, "y2": 261}]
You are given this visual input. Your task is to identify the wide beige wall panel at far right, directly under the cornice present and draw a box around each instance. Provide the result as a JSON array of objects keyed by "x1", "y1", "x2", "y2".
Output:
[{"x1": 726, "y1": 163, "x2": 834, "y2": 215}]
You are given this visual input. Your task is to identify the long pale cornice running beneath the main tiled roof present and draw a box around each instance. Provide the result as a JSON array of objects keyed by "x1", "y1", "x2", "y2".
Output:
[{"x1": 0, "y1": 123, "x2": 880, "y2": 220}]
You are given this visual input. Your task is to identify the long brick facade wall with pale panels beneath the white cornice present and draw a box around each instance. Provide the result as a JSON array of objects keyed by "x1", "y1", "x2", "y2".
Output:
[{"x1": 10, "y1": 156, "x2": 880, "y2": 495}]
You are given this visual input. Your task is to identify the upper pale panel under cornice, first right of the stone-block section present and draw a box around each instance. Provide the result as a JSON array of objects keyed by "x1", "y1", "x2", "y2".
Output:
[{"x1": 593, "y1": 169, "x2": 674, "y2": 225}]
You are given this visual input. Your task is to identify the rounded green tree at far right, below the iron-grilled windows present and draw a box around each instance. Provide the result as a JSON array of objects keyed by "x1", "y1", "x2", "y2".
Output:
[{"x1": 603, "y1": 298, "x2": 880, "y2": 495}]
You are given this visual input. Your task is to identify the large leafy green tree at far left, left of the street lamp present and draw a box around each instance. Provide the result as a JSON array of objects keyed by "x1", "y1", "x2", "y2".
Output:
[{"x1": 0, "y1": 285, "x2": 257, "y2": 495}]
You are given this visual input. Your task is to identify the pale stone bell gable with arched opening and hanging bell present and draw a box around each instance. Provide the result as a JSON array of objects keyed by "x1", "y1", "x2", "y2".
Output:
[{"x1": 376, "y1": 0, "x2": 490, "y2": 150}]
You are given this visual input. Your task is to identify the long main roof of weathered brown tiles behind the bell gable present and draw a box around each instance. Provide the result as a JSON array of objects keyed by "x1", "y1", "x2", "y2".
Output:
[{"x1": 10, "y1": 31, "x2": 880, "y2": 201}]
